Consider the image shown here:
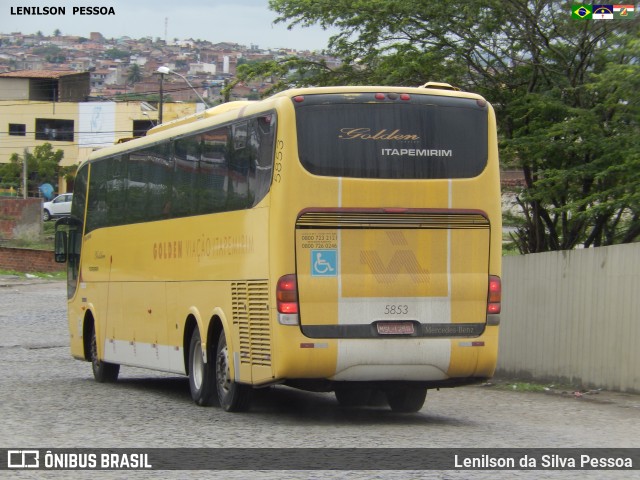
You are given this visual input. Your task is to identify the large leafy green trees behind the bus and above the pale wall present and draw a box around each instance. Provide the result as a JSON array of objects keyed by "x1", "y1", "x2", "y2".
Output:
[{"x1": 242, "y1": 0, "x2": 640, "y2": 253}]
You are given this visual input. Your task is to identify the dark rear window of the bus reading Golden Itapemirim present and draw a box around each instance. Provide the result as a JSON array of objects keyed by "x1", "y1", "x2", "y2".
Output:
[{"x1": 294, "y1": 94, "x2": 488, "y2": 179}]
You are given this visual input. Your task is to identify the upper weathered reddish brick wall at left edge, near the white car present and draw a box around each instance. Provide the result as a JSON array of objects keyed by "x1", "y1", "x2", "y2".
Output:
[{"x1": 0, "y1": 197, "x2": 42, "y2": 240}]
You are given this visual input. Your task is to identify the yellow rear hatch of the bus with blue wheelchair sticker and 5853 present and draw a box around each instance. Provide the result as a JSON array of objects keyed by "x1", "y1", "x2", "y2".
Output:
[{"x1": 296, "y1": 210, "x2": 490, "y2": 338}]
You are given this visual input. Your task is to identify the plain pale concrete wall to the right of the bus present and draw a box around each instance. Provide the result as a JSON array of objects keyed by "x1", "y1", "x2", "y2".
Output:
[{"x1": 497, "y1": 243, "x2": 640, "y2": 392}]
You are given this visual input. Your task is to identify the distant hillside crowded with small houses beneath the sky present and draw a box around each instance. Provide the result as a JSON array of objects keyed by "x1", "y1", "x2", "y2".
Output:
[{"x1": 0, "y1": 32, "x2": 332, "y2": 101}]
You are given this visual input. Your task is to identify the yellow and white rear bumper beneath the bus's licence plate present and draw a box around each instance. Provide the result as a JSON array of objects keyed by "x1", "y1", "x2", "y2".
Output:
[{"x1": 274, "y1": 326, "x2": 498, "y2": 384}]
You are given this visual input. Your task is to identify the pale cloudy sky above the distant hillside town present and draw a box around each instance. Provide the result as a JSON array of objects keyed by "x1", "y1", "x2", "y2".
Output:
[{"x1": 0, "y1": 0, "x2": 335, "y2": 50}]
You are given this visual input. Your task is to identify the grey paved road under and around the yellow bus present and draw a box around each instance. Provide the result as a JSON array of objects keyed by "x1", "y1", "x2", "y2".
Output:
[{"x1": 0, "y1": 279, "x2": 640, "y2": 479}]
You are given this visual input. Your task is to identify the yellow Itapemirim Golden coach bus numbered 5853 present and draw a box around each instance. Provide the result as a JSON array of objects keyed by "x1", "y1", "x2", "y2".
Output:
[{"x1": 55, "y1": 84, "x2": 501, "y2": 412}]
